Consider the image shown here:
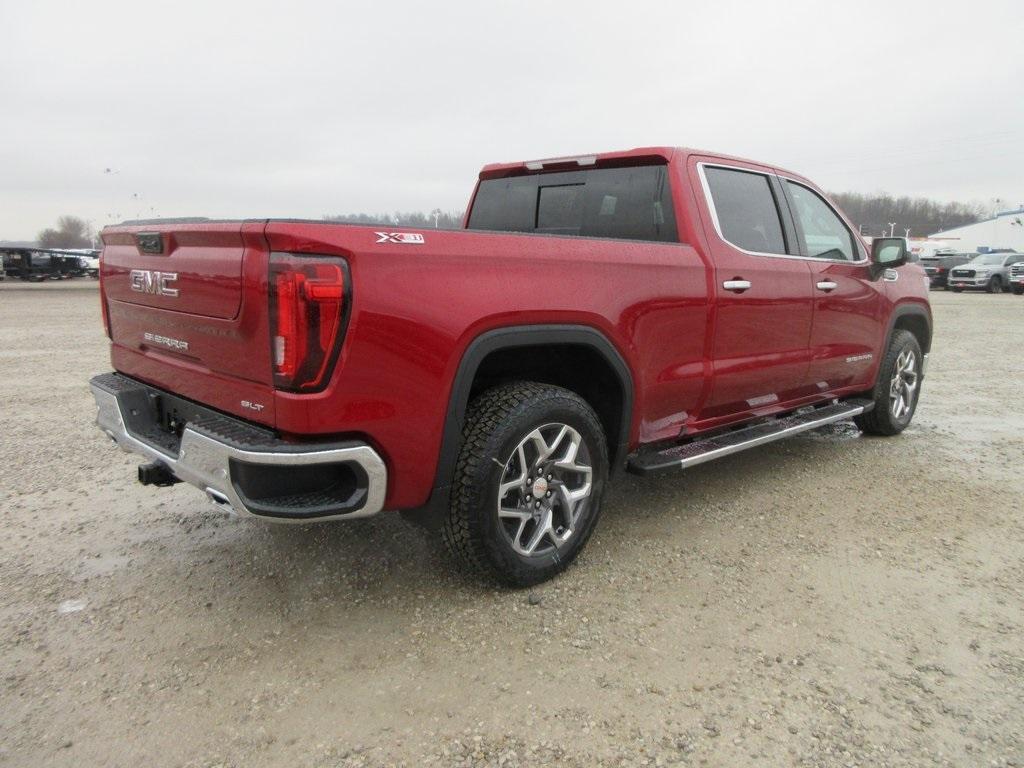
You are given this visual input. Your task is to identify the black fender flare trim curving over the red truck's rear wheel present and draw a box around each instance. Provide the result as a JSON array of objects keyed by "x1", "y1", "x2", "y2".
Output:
[{"x1": 426, "y1": 325, "x2": 634, "y2": 510}]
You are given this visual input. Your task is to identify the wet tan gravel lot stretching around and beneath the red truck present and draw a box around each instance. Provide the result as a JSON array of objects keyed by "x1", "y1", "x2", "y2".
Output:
[{"x1": 0, "y1": 281, "x2": 1024, "y2": 768}]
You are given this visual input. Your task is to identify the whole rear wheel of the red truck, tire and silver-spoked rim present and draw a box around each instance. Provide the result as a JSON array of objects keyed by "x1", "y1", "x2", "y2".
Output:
[{"x1": 442, "y1": 382, "x2": 608, "y2": 587}]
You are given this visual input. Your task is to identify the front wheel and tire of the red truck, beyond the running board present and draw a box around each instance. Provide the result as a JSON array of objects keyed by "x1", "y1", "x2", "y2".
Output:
[{"x1": 854, "y1": 329, "x2": 924, "y2": 435}]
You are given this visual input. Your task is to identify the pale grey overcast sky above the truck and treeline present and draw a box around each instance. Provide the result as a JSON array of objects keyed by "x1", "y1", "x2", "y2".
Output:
[{"x1": 0, "y1": 0, "x2": 1024, "y2": 240}]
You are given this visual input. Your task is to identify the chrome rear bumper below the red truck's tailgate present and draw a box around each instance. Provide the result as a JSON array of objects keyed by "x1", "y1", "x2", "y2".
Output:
[{"x1": 90, "y1": 374, "x2": 387, "y2": 522}]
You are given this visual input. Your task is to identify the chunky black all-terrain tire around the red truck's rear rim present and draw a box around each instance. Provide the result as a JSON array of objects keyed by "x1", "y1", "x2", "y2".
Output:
[{"x1": 441, "y1": 382, "x2": 608, "y2": 587}]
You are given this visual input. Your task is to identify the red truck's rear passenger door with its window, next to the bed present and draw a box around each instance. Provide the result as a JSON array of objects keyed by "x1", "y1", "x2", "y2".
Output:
[{"x1": 690, "y1": 158, "x2": 814, "y2": 421}]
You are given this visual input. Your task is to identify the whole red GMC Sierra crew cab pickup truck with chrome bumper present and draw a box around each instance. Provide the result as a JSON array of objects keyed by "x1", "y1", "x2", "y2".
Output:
[{"x1": 91, "y1": 147, "x2": 932, "y2": 585}]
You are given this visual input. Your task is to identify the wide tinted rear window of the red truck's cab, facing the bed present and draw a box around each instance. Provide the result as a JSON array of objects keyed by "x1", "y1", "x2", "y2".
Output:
[{"x1": 468, "y1": 165, "x2": 679, "y2": 243}]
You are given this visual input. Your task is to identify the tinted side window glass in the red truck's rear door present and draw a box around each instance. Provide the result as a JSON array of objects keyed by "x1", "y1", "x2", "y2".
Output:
[{"x1": 703, "y1": 166, "x2": 786, "y2": 254}]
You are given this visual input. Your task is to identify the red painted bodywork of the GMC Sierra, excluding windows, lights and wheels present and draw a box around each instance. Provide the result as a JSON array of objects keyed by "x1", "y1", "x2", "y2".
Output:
[{"x1": 101, "y1": 147, "x2": 927, "y2": 509}]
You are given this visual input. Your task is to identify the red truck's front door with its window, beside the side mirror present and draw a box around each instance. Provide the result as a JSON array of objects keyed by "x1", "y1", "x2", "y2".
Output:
[{"x1": 782, "y1": 178, "x2": 889, "y2": 392}]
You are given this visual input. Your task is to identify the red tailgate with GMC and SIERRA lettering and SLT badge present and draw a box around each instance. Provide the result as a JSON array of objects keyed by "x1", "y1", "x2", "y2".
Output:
[{"x1": 100, "y1": 221, "x2": 273, "y2": 426}]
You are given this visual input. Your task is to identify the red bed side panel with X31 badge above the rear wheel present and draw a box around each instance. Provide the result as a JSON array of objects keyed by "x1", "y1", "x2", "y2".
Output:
[{"x1": 265, "y1": 221, "x2": 708, "y2": 508}]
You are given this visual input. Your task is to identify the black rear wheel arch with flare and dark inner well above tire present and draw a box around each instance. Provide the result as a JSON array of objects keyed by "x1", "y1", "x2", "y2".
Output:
[{"x1": 427, "y1": 325, "x2": 634, "y2": 509}]
